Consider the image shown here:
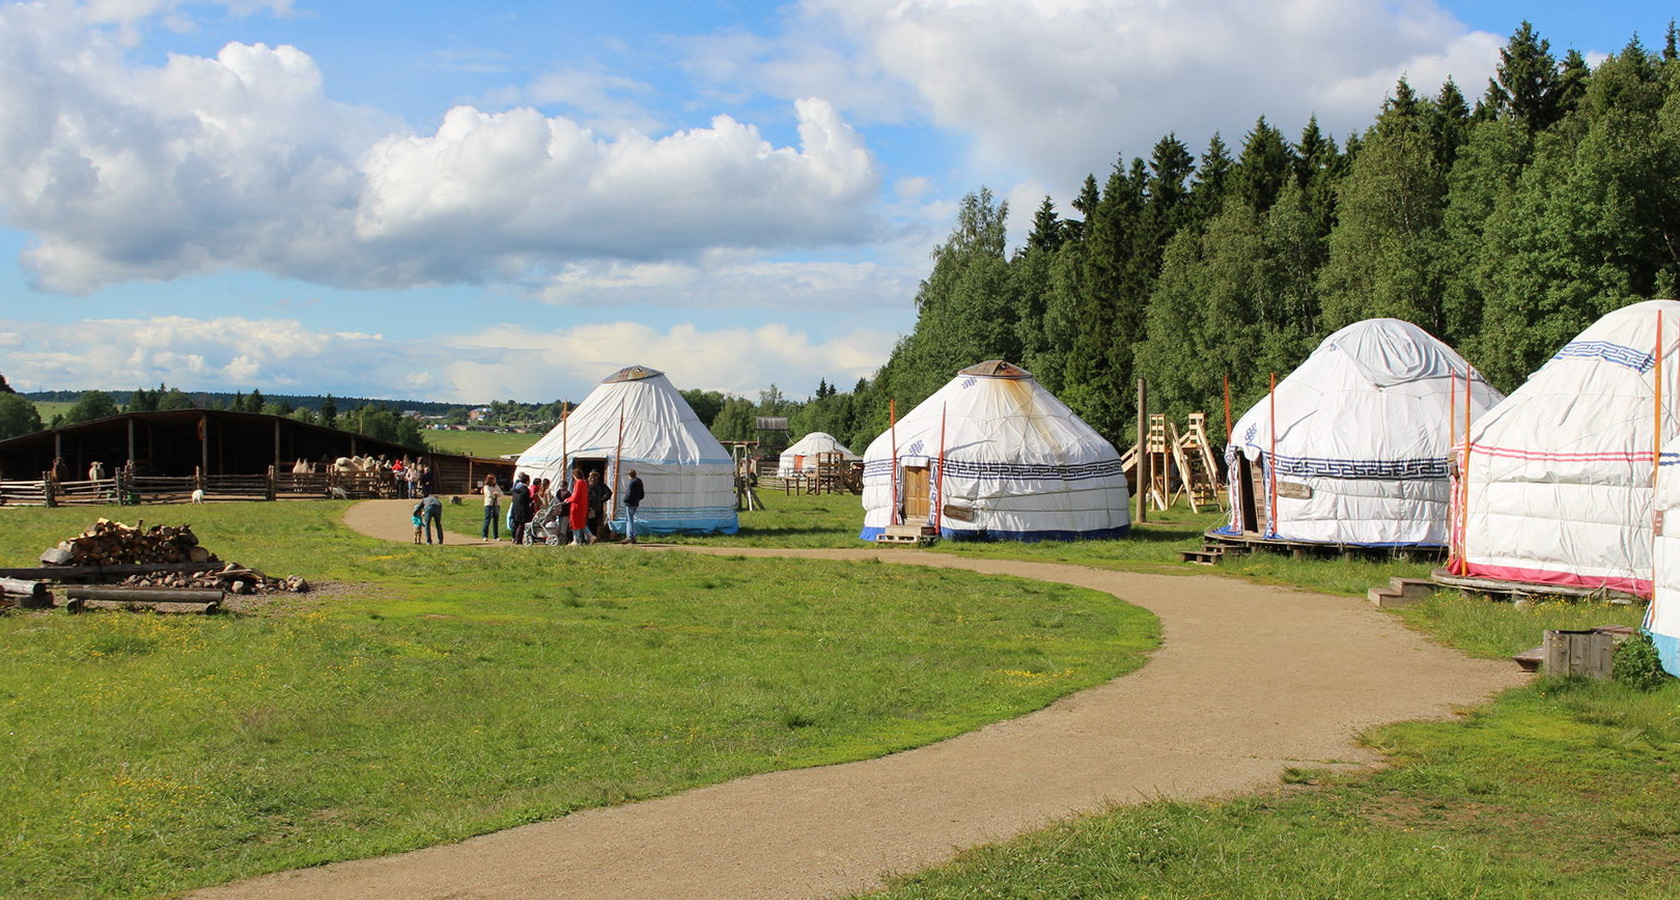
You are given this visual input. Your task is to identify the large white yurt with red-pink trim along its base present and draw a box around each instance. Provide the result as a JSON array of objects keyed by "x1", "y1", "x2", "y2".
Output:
[{"x1": 1455, "y1": 301, "x2": 1680, "y2": 596}]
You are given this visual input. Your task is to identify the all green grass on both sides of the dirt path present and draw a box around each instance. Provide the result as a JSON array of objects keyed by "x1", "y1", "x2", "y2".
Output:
[{"x1": 0, "y1": 492, "x2": 1680, "y2": 898}]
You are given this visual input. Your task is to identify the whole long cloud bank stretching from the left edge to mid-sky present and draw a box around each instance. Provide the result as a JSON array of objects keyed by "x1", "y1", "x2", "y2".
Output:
[{"x1": 0, "y1": 0, "x2": 879, "y2": 294}]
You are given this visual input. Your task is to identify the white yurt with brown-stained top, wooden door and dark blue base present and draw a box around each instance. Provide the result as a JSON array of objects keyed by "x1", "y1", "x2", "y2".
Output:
[{"x1": 858, "y1": 359, "x2": 1131, "y2": 541}]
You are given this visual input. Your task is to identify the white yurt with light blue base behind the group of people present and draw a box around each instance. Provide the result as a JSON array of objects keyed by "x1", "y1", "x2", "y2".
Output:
[{"x1": 517, "y1": 366, "x2": 739, "y2": 534}]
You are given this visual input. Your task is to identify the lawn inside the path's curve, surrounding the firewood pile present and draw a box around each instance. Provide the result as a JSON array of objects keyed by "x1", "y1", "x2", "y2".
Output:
[{"x1": 0, "y1": 502, "x2": 1158, "y2": 898}]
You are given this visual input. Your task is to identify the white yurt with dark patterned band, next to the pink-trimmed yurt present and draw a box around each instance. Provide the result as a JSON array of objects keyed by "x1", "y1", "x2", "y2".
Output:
[{"x1": 1216, "y1": 319, "x2": 1500, "y2": 547}]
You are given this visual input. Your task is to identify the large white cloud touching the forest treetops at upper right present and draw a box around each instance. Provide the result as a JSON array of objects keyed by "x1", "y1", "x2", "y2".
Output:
[{"x1": 779, "y1": 0, "x2": 1504, "y2": 188}]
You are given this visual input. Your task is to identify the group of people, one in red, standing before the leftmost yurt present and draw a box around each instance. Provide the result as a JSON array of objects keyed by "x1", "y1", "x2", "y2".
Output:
[{"x1": 480, "y1": 468, "x2": 645, "y2": 546}]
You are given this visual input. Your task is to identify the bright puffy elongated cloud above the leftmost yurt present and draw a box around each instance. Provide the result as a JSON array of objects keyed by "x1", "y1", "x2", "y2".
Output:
[{"x1": 356, "y1": 101, "x2": 877, "y2": 267}]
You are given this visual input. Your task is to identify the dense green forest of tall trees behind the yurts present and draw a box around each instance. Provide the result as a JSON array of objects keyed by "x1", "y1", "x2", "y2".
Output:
[{"x1": 759, "y1": 22, "x2": 1680, "y2": 450}]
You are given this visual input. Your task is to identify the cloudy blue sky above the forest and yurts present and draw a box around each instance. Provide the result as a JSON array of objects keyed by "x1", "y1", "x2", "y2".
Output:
[{"x1": 0, "y1": 0, "x2": 1673, "y2": 403}]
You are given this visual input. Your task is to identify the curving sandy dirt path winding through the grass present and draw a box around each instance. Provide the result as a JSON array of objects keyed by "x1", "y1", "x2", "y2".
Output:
[{"x1": 195, "y1": 500, "x2": 1524, "y2": 900}]
